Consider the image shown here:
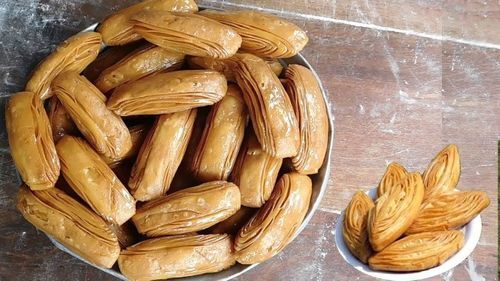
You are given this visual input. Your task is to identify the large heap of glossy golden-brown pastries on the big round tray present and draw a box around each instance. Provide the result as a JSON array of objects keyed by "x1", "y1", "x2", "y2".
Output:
[{"x1": 6, "y1": 0, "x2": 329, "y2": 280}]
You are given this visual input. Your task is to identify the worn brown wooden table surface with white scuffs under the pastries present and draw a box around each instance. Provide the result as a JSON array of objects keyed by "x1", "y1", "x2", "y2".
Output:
[{"x1": 0, "y1": 0, "x2": 500, "y2": 281}]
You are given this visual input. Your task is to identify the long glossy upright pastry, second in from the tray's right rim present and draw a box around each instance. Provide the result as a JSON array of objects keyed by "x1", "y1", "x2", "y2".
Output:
[{"x1": 236, "y1": 54, "x2": 300, "y2": 158}]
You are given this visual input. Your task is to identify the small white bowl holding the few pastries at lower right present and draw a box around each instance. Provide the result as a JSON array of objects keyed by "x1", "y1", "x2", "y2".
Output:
[{"x1": 335, "y1": 188, "x2": 482, "y2": 281}]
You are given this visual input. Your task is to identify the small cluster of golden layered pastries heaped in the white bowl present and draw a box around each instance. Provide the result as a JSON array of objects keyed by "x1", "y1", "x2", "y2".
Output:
[{"x1": 343, "y1": 145, "x2": 490, "y2": 272}]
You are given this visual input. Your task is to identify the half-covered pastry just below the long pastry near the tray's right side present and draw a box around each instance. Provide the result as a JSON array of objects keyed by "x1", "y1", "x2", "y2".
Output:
[{"x1": 231, "y1": 130, "x2": 283, "y2": 208}]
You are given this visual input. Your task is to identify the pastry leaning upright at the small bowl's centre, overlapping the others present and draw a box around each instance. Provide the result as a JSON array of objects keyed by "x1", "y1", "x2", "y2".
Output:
[{"x1": 368, "y1": 173, "x2": 424, "y2": 252}]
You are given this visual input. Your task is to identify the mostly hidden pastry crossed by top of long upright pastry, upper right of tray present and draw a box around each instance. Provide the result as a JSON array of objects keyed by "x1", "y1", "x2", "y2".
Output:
[{"x1": 187, "y1": 56, "x2": 283, "y2": 82}]
